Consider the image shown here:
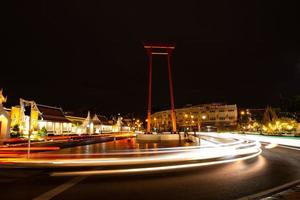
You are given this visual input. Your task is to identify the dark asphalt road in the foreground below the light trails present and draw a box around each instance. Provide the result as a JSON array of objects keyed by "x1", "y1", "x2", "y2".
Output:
[{"x1": 0, "y1": 144, "x2": 300, "y2": 200}]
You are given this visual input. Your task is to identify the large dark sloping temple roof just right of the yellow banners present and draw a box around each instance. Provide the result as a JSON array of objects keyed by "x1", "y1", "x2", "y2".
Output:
[{"x1": 37, "y1": 104, "x2": 70, "y2": 123}]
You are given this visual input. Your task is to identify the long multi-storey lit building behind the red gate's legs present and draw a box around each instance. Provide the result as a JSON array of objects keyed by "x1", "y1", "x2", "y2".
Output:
[{"x1": 151, "y1": 103, "x2": 238, "y2": 131}]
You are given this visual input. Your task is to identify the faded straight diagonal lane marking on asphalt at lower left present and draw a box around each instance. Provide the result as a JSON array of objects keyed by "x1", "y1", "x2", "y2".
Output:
[{"x1": 33, "y1": 176, "x2": 87, "y2": 200}]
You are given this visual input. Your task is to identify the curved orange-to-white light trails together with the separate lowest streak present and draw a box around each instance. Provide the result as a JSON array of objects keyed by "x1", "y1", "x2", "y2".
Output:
[{"x1": 0, "y1": 136, "x2": 262, "y2": 176}]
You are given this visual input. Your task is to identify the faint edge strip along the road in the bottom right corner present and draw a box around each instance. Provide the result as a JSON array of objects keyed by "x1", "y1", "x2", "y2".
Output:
[{"x1": 238, "y1": 179, "x2": 300, "y2": 200}]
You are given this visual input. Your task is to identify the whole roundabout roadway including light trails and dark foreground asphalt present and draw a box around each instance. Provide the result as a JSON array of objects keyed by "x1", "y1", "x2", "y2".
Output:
[{"x1": 0, "y1": 133, "x2": 300, "y2": 199}]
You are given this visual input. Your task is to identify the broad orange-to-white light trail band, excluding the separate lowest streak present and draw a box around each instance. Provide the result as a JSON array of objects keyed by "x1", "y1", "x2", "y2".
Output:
[{"x1": 0, "y1": 135, "x2": 261, "y2": 168}]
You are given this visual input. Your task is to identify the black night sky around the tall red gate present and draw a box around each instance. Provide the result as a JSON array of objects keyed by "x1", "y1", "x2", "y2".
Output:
[{"x1": 0, "y1": 0, "x2": 300, "y2": 117}]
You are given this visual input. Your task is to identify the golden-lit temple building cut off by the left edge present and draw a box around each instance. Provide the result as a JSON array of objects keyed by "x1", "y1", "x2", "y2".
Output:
[{"x1": 0, "y1": 89, "x2": 10, "y2": 142}]
